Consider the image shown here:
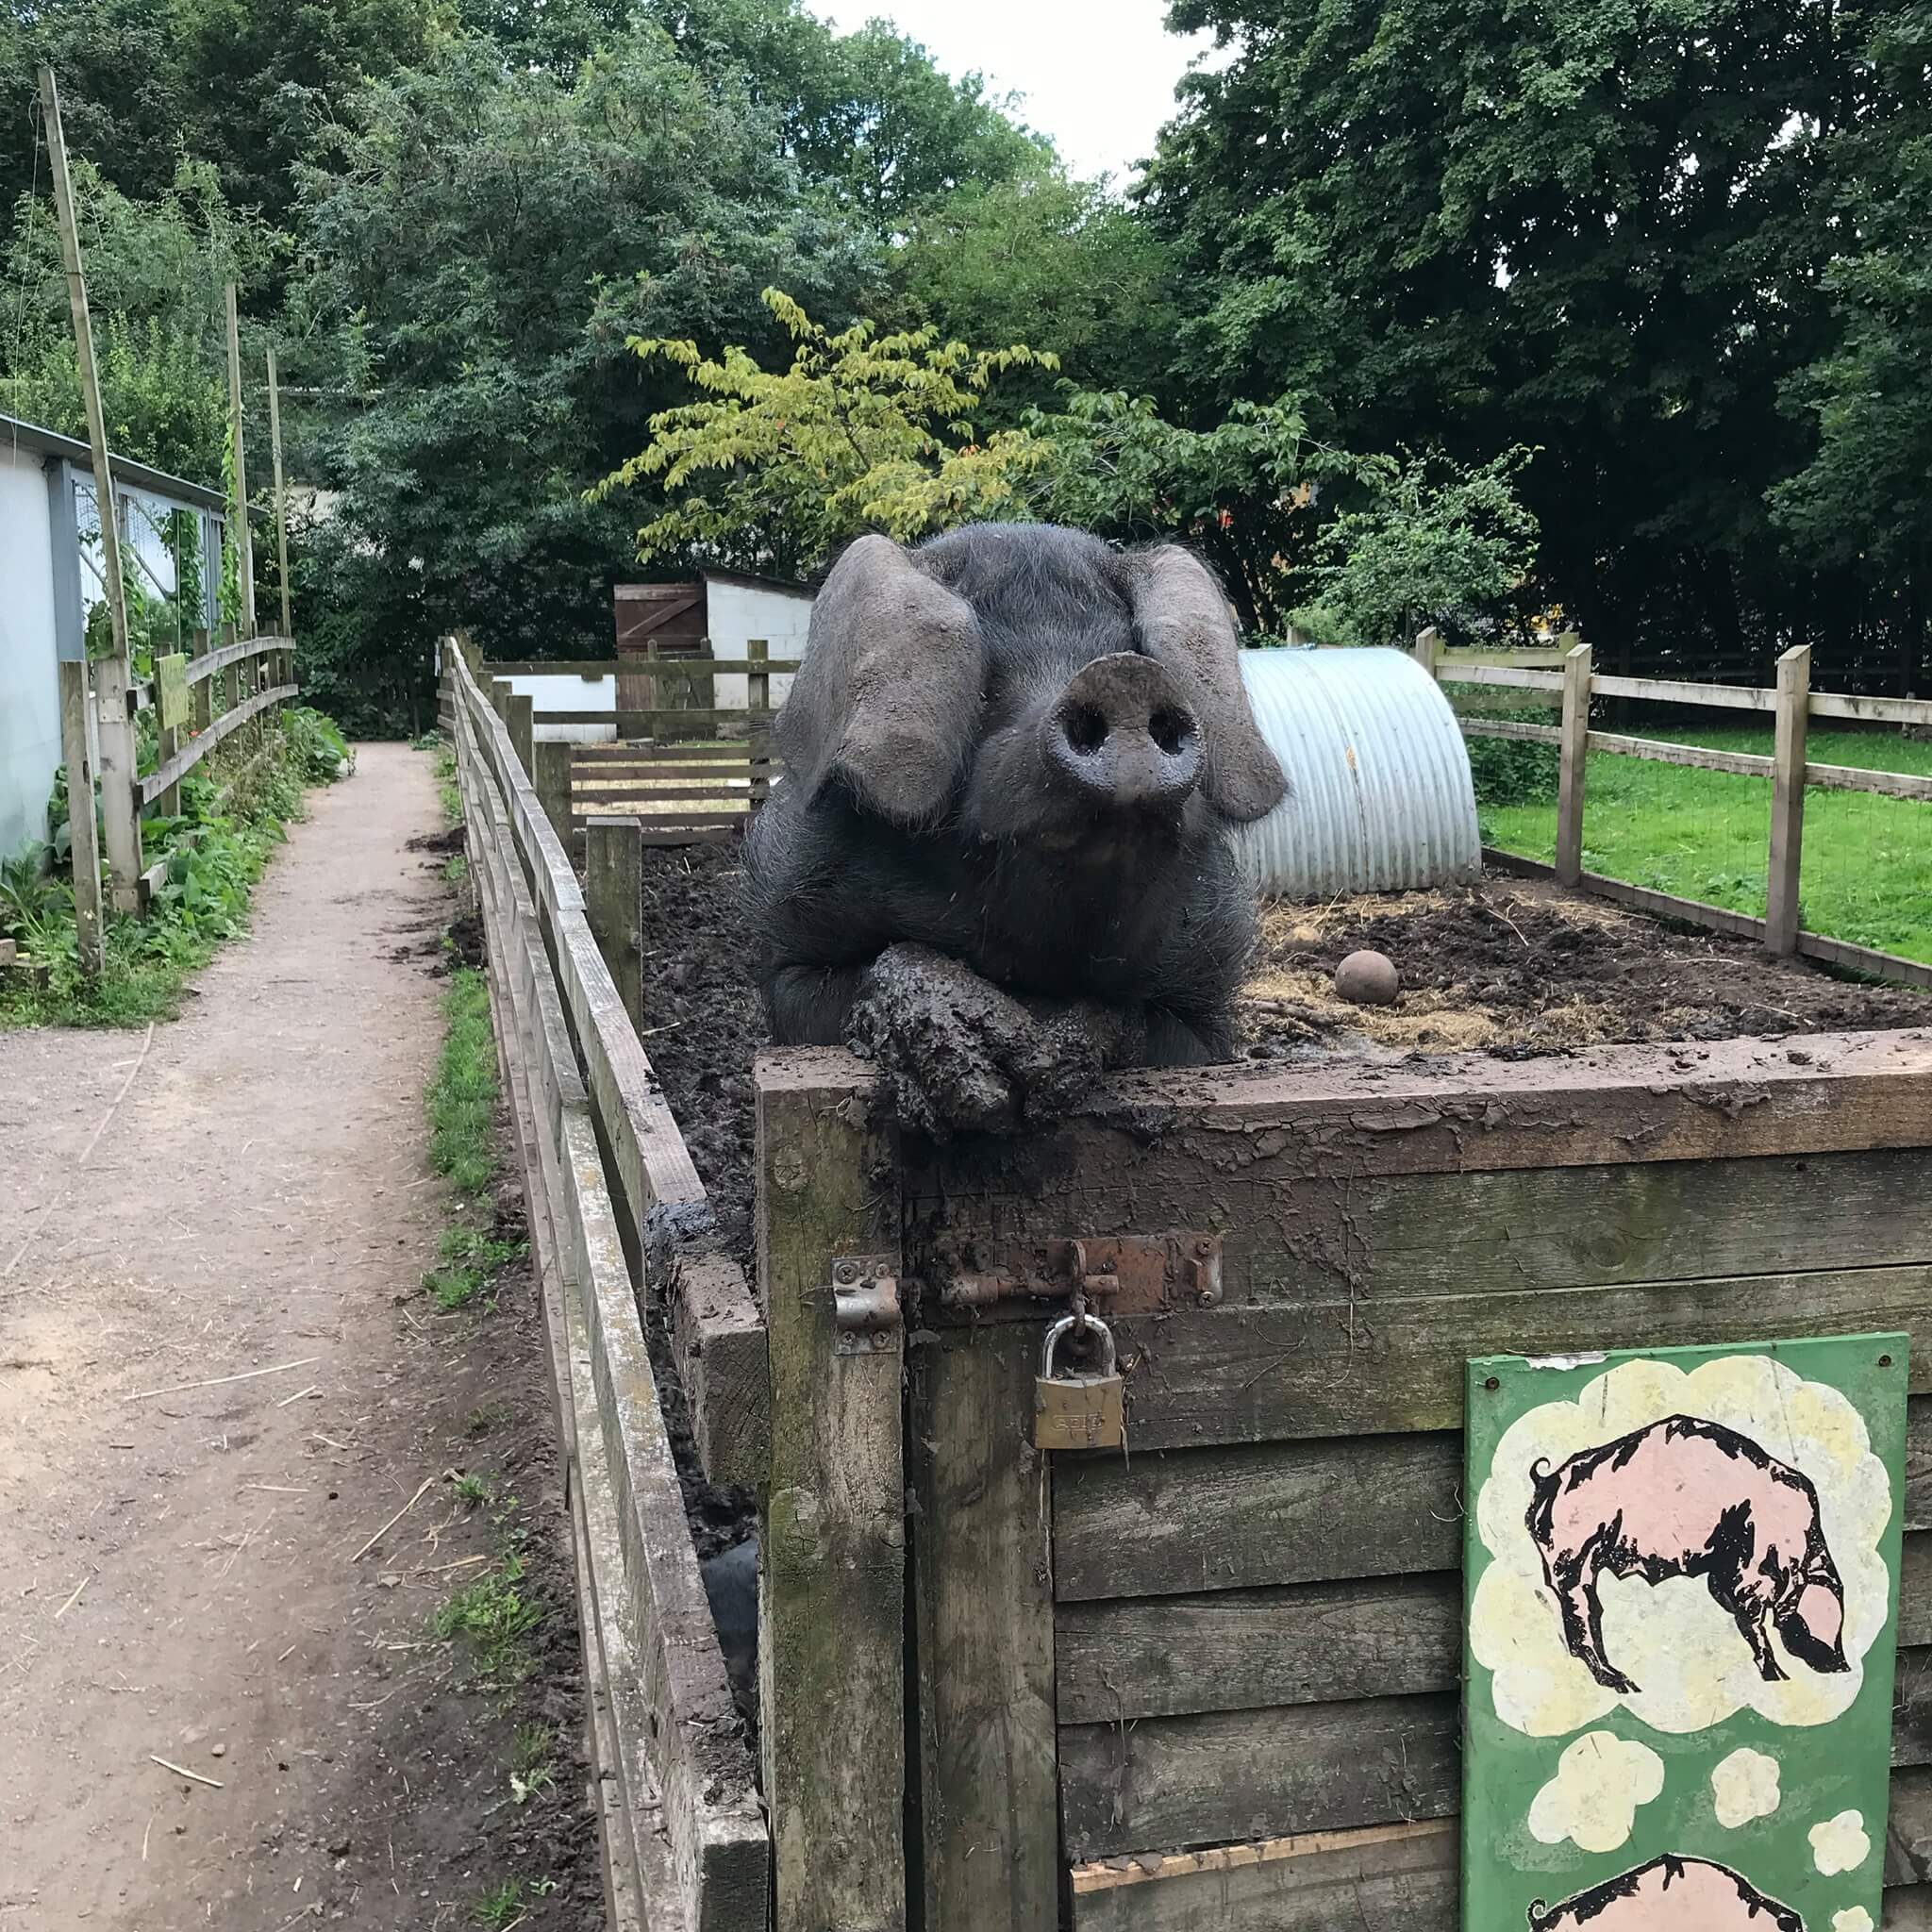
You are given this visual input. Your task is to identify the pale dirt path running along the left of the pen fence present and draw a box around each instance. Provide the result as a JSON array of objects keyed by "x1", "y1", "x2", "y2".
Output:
[{"x1": 0, "y1": 746, "x2": 601, "y2": 1932}]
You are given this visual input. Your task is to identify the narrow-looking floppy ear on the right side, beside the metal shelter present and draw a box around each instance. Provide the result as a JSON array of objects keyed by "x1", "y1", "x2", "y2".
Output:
[{"x1": 1128, "y1": 542, "x2": 1289, "y2": 821}]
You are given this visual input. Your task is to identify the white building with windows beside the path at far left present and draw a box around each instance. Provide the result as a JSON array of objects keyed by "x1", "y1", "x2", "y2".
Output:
[{"x1": 0, "y1": 415, "x2": 225, "y2": 852}]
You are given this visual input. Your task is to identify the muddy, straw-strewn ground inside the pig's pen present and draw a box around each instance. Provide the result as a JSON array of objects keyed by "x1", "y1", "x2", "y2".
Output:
[{"x1": 641, "y1": 846, "x2": 1932, "y2": 1228}]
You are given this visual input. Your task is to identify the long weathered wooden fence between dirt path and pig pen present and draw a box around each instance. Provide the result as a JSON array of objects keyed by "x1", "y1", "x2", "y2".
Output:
[{"x1": 448, "y1": 649, "x2": 769, "y2": 1932}]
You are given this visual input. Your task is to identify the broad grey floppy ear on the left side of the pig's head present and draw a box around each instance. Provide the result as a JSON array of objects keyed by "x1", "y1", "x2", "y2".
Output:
[{"x1": 776, "y1": 537, "x2": 981, "y2": 824}]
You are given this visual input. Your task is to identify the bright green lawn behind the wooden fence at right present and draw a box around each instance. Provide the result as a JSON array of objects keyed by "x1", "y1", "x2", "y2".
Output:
[{"x1": 1478, "y1": 724, "x2": 1932, "y2": 962}]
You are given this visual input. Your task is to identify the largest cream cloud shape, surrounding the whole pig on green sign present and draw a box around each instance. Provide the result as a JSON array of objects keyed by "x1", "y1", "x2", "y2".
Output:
[{"x1": 1468, "y1": 1355, "x2": 1891, "y2": 1737}]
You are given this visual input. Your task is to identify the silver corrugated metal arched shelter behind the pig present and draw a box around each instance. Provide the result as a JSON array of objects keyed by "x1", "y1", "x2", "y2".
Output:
[{"x1": 1235, "y1": 647, "x2": 1482, "y2": 898}]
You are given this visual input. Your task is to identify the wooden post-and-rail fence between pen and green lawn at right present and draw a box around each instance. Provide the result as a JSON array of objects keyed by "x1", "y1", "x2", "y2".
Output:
[{"x1": 1414, "y1": 630, "x2": 1932, "y2": 988}]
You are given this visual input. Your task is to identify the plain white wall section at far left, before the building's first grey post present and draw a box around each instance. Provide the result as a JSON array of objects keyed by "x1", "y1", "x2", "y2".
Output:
[{"x1": 0, "y1": 441, "x2": 59, "y2": 854}]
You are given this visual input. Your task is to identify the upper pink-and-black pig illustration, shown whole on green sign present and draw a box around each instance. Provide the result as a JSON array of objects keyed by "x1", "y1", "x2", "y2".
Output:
[{"x1": 1526, "y1": 1416, "x2": 1851, "y2": 1700}]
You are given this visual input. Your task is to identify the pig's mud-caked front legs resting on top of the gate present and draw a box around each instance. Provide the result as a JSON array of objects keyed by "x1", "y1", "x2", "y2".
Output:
[{"x1": 848, "y1": 944, "x2": 1143, "y2": 1140}]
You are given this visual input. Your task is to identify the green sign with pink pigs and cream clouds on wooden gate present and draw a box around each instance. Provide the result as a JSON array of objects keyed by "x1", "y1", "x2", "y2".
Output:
[{"x1": 1462, "y1": 1335, "x2": 1907, "y2": 1932}]
